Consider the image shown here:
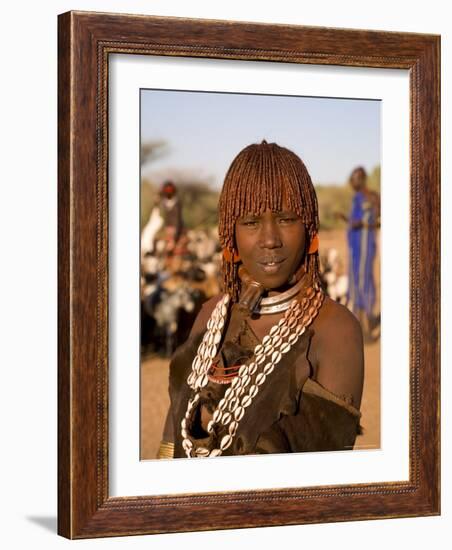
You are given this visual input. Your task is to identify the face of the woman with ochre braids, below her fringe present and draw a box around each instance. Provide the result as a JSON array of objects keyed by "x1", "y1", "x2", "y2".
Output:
[{"x1": 235, "y1": 203, "x2": 306, "y2": 290}]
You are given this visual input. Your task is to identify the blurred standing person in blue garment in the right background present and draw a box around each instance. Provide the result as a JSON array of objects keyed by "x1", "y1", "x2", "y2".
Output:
[{"x1": 339, "y1": 166, "x2": 380, "y2": 339}]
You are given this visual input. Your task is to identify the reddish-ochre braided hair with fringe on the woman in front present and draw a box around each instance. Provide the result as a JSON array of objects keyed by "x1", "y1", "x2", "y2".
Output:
[{"x1": 218, "y1": 140, "x2": 320, "y2": 301}]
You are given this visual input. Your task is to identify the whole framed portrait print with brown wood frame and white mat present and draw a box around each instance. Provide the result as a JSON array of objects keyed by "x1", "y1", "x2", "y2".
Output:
[{"x1": 58, "y1": 12, "x2": 440, "y2": 538}]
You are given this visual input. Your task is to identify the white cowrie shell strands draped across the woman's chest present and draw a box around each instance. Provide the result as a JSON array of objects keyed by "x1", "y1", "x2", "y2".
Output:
[{"x1": 181, "y1": 283, "x2": 324, "y2": 458}]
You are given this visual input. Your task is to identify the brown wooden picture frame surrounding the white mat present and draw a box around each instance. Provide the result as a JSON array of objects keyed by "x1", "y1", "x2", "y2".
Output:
[{"x1": 58, "y1": 12, "x2": 440, "y2": 538}]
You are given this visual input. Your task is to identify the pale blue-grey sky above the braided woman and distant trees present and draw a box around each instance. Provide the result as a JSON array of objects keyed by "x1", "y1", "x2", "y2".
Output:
[{"x1": 141, "y1": 90, "x2": 381, "y2": 188}]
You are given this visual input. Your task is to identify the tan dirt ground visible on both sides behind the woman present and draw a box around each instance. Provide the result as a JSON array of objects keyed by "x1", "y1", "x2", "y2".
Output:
[{"x1": 140, "y1": 231, "x2": 380, "y2": 459}]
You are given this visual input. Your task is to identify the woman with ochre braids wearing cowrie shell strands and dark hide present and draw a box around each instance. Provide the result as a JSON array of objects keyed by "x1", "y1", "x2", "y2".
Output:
[{"x1": 159, "y1": 141, "x2": 363, "y2": 458}]
